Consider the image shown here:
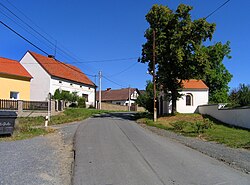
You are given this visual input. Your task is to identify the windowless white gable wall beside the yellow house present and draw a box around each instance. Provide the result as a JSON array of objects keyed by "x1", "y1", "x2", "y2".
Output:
[{"x1": 20, "y1": 52, "x2": 50, "y2": 101}]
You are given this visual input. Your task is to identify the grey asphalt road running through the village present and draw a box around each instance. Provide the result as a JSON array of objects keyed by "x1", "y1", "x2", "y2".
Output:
[{"x1": 73, "y1": 114, "x2": 250, "y2": 185}]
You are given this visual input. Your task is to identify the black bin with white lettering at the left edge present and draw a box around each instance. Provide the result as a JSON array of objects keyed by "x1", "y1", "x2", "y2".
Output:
[{"x1": 0, "y1": 111, "x2": 17, "y2": 135}]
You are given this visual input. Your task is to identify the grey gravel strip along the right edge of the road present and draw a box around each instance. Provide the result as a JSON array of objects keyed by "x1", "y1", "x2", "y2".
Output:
[{"x1": 140, "y1": 124, "x2": 250, "y2": 174}]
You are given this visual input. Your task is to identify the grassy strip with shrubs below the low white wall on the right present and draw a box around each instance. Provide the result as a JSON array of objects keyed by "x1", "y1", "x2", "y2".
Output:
[{"x1": 137, "y1": 113, "x2": 250, "y2": 149}]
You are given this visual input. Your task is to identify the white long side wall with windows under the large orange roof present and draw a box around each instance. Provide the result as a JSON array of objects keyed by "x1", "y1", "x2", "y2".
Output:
[{"x1": 50, "y1": 77, "x2": 95, "y2": 106}]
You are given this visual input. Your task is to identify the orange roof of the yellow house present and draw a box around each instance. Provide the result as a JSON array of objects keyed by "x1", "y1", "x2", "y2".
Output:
[{"x1": 0, "y1": 57, "x2": 32, "y2": 79}]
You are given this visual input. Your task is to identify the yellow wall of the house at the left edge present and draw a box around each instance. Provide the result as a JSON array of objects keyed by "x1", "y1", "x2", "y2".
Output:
[{"x1": 0, "y1": 75, "x2": 30, "y2": 101}]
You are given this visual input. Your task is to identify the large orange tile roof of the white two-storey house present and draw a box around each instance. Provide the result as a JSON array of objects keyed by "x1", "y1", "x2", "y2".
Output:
[{"x1": 29, "y1": 51, "x2": 95, "y2": 86}]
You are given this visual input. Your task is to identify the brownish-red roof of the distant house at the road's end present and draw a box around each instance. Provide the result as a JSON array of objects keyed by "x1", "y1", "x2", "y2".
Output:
[{"x1": 96, "y1": 88, "x2": 137, "y2": 101}]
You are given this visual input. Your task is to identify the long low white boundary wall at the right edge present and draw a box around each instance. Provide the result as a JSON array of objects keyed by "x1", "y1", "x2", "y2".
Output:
[{"x1": 198, "y1": 105, "x2": 250, "y2": 129}]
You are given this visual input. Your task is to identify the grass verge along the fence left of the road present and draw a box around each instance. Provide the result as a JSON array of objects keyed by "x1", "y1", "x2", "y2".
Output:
[{"x1": 0, "y1": 108, "x2": 110, "y2": 142}]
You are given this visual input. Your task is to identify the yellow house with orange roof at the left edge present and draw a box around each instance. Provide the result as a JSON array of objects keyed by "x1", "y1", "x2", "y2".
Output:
[{"x1": 0, "y1": 58, "x2": 32, "y2": 100}]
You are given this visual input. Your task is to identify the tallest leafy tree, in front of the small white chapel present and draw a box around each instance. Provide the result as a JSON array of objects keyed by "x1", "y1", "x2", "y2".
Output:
[{"x1": 140, "y1": 4, "x2": 231, "y2": 114}]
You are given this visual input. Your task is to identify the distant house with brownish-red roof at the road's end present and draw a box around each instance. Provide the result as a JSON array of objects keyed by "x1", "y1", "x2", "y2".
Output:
[{"x1": 96, "y1": 88, "x2": 140, "y2": 106}]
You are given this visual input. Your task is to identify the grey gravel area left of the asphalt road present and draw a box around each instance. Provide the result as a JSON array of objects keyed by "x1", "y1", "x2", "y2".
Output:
[{"x1": 0, "y1": 123, "x2": 79, "y2": 185}]
